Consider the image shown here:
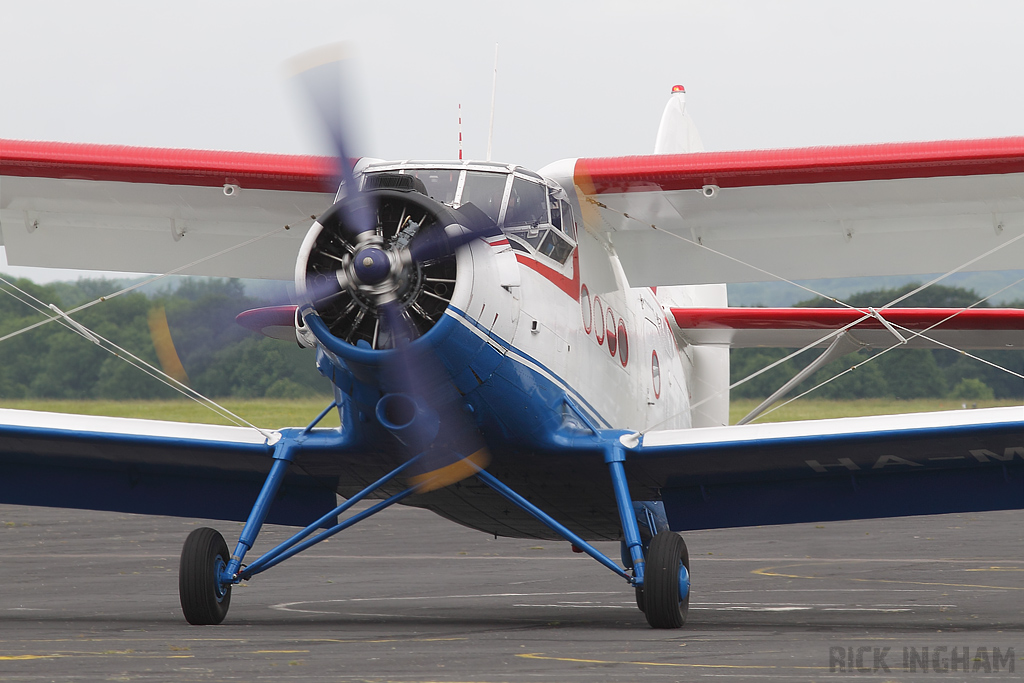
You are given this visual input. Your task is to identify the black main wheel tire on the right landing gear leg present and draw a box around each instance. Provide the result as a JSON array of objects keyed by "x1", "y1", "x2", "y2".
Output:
[{"x1": 637, "y1": 531, "x2": 690, "y2": 629}]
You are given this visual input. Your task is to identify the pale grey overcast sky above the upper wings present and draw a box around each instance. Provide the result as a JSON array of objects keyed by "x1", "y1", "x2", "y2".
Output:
[{"x1": 6, "y1": 0, "x2": 1024, "y2": 282}]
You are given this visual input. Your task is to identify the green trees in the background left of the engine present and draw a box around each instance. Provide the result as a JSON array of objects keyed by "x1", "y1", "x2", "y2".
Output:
[{"x1": 0, "y1": 279, "x2": 331, "y2": 399}]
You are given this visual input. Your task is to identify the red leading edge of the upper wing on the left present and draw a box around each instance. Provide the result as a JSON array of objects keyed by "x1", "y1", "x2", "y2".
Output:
[{"x1": 0, "y1": 139, "x2": 337, "y2": 193}]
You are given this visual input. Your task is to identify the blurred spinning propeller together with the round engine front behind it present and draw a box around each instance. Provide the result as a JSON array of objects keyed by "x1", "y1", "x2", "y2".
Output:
[{"x1": 294, "y1": 48, "x2": 497, "y2": 492}]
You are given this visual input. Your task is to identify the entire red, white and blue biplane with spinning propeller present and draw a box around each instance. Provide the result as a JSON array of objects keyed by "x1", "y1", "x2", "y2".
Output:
[{"x1": 0, "y1": 76, "x2": 1024, "y2": 628}]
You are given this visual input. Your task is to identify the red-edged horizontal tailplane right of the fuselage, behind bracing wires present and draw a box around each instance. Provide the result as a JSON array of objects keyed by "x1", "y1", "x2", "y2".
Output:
[{"x1": 671, "y1": 308, "x2": 1024, "y2": 349}]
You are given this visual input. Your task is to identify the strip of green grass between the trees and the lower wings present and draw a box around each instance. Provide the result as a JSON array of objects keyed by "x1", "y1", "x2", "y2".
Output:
[{"x1": 0, "y1": 398, "x2": 1024, "y2": 429}]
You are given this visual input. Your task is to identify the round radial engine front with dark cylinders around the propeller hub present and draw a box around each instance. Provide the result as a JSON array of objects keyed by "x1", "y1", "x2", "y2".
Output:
[{"x1": 295, "y1": 179, "x2": 476, "y2": 349}]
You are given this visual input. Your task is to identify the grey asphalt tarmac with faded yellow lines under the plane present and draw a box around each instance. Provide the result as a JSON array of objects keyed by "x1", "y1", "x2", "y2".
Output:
[{"x1": 0, "y1": 499, "x2": 1024, "y2": 682}]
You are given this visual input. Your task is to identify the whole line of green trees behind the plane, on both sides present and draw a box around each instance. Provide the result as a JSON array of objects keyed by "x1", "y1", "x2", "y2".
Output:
[{"x1": 0, "y1": 279, "x2": 1024, "y2": 399}]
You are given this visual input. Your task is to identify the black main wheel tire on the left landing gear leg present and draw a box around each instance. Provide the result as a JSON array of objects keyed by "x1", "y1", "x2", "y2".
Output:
[{"x1": 178, "y1": 526, "x2": 231, "y2": 626}]
